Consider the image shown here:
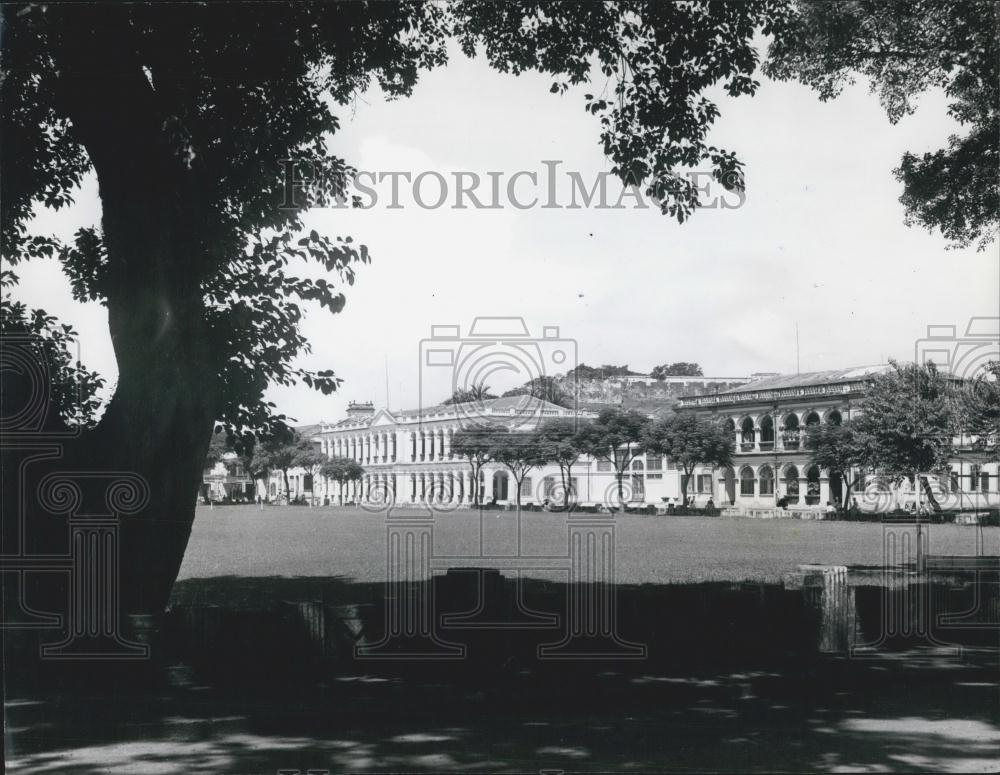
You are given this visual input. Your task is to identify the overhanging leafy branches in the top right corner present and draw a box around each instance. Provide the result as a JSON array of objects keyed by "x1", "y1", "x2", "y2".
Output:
[{"x1": 764, "y1": 0, "x2": 1000, "y2": 250}]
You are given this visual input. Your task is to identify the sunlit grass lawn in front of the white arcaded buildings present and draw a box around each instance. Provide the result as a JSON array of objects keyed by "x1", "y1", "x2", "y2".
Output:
[{"x1": 180, "y1": 506, "x2": 1000, "y2": 583}]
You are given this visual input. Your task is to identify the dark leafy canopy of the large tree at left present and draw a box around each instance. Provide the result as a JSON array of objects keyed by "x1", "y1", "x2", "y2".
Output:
[{"x1": 0, "y1": 0, "x2": 781, "y2": 439}]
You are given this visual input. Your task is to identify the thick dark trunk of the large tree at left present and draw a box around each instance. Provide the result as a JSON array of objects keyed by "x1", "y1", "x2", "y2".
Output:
[{"x1": 43, "y1": 25, "x2": 219, "y2": 613}]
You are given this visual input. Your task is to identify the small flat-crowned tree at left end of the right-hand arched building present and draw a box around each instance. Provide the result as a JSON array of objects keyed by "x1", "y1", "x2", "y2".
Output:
[{"x1": 645, "y1": 414, "x2": 733, "y2": 505}]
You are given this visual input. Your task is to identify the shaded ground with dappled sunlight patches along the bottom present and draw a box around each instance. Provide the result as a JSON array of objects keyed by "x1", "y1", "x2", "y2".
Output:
[{"x1": 7, "y1": 655, "x2": 1000, "y2": 775}]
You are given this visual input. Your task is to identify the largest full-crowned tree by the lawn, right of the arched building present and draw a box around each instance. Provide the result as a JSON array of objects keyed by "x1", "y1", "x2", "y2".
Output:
[{"x1": 856, "y1": 361, "x2": 958, "y2": 508}]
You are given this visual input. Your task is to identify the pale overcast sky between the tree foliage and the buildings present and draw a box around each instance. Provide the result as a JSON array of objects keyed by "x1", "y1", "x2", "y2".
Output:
[{"x1": 16, "y1": 45, "x2": 1000, "y2": 422}]
